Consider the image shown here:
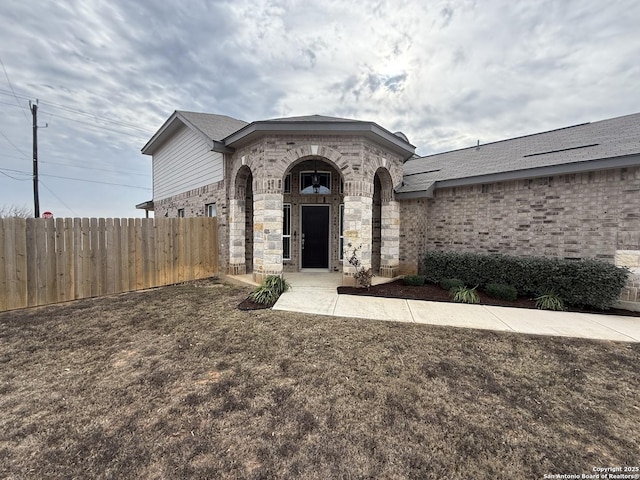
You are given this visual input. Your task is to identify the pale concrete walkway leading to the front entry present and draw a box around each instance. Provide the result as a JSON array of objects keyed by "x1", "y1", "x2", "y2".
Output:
[{"x1": 273, "y1": 273, "x2": 640, "y2": 342}]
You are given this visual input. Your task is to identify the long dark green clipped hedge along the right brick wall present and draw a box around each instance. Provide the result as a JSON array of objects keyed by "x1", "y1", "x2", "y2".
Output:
[{"x1": 424, "y1": 252, "x2": 629, "y2": 309}]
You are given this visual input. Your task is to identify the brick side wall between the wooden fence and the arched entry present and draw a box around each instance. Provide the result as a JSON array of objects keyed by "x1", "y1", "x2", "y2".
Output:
[{"x1": 153, "y1": 181, "x2": 229, "y2": 272}]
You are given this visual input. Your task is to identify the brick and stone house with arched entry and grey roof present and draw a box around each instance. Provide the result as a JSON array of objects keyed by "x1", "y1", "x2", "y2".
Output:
[{"x1": 141, "y1": 111, "x2": 640, "y2": 302}]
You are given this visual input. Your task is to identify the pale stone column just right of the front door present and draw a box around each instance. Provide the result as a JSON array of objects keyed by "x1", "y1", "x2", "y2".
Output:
[{"x1": 342, "y1": 196, "x2": 373, "y2": 285}]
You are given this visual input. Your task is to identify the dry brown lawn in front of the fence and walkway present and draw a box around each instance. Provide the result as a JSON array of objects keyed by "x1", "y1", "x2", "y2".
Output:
[{"x1": 0, "y1": 281, "x2": 640, "y2": 479}]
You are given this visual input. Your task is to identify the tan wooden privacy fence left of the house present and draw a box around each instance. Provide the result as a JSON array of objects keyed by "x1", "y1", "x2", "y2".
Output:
[{"x1": 0, "y1": 217, "x2": 218, "y2": 311}]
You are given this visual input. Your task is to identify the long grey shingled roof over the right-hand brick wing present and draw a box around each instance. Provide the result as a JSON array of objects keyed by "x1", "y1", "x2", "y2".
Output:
[{"x1": 396, "y1": 113, "x2": 640, "y2": 198}]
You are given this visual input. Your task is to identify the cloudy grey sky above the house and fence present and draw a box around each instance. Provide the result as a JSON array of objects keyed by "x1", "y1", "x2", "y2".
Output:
[{"x1": 0, "y1": 0, "x2": 640, "y2": 217}]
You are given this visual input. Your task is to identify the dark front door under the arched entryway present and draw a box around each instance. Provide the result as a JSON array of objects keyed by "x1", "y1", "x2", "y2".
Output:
[{"x1": 302, "y1": 205, "x2": 329, "y2": 268}]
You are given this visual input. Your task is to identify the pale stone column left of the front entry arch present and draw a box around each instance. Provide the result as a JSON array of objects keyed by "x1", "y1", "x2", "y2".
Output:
[{"x1": 253, "y1": 193, "x2": 282, "y2": 282}]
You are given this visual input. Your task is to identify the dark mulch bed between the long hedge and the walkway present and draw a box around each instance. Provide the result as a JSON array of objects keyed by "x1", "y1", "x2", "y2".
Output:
[{"x1": 338, "y1": 280, "x2": 640, "y2": 317}]
